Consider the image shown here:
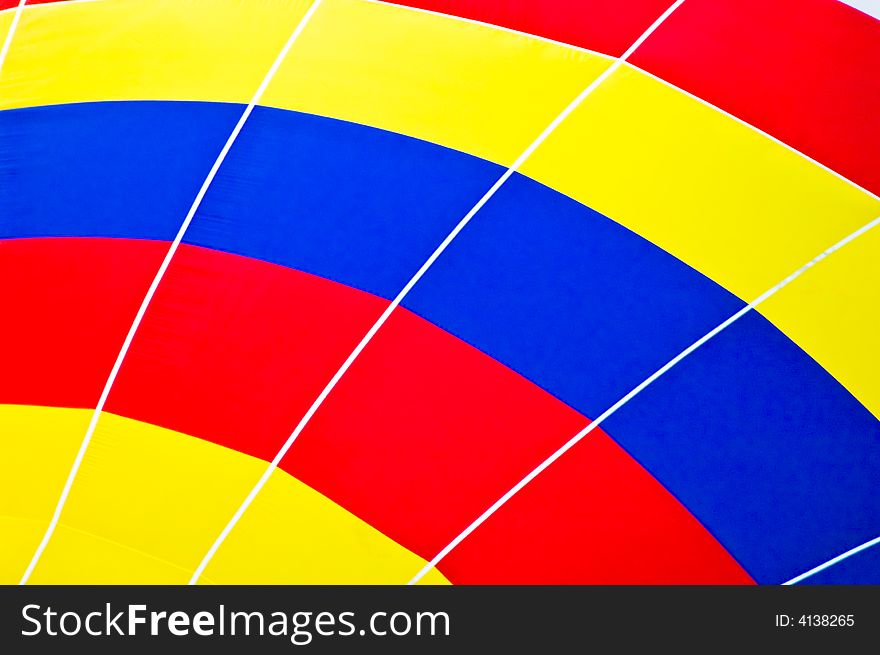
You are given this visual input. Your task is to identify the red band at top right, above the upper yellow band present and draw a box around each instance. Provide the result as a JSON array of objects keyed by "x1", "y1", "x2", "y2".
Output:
[{"x1": 397, "y1": 0, "x2": 880, "y2": 193}]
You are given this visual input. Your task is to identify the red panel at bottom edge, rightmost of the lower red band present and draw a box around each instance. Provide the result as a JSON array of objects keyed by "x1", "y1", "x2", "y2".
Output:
[{"x1": 439, "y1": 431, "x2": 754, "y2": 584}]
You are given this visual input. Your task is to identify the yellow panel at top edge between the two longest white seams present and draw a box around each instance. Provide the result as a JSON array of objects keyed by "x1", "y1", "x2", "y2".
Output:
[{"x1": 262, "y1": 0, "x2": 610, "y2": 164}]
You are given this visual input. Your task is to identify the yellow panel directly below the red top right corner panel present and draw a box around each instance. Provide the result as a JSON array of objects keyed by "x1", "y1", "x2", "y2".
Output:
[{"x1": 522, "y1": 66, "x2": 880, "y2": 301}]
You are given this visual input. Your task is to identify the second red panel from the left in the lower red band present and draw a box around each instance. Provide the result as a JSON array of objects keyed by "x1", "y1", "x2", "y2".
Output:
[{"x1": 107, "y1": 245, "x2": 387, "y2": 460}]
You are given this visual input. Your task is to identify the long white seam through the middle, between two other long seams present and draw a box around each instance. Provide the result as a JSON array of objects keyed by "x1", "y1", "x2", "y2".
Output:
[{"x1": 189, "y1": 0, "x2": 685, "y2": 585}]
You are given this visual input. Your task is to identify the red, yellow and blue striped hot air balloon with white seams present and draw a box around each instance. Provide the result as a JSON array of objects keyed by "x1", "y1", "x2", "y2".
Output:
[{"x1": 0, "y1": 0, "x2": 880, "y2": 584}]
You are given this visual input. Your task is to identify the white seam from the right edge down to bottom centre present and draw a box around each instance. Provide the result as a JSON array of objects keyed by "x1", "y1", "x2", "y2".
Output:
[{"x1": 407, "y1": 216, "x2": 880, "y2": 585}]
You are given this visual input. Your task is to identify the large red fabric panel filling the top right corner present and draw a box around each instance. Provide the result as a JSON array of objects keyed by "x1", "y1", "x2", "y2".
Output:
[{"x1": 631, "y1": 0, "x2": 880, "y2": 192}]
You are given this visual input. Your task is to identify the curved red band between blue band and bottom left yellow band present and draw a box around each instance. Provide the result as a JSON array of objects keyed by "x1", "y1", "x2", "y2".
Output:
[{"x1": 6, "y1": 238, "x2": 746, "y2": 583}]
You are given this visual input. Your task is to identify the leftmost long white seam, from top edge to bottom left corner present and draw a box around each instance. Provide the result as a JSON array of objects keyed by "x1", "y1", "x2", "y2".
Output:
[{"x1": 19, "y1": 0, "x2": 322, "y2": 585}]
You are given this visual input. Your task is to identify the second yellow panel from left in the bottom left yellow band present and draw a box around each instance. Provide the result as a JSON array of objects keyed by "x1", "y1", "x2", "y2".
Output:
[{"x1": 31, "y1": 413, "x2": 265, "y2": 584}]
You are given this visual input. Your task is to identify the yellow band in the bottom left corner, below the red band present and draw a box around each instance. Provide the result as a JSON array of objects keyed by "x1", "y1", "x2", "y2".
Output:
[{"x1": 0, "y1": 406, "x2": 446, "y2": 584}]
